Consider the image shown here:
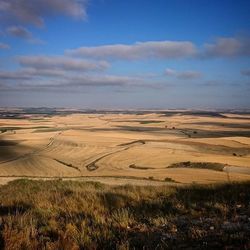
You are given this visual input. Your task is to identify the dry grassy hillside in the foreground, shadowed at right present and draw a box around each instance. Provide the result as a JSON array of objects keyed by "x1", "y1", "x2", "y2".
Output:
[{"x1": 0, "y1": 179, "x2": 250, "y2": 250}]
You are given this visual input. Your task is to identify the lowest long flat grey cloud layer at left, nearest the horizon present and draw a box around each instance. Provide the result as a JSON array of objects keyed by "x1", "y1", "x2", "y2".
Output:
[{"x1": 0, "y1": 71, "x2": 152, "y2": 91}]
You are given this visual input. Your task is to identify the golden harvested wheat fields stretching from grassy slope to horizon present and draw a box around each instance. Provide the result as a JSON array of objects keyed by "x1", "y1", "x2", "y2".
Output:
[{"x1": 0, "y1": 109, "x2": 250, "y2": 185}]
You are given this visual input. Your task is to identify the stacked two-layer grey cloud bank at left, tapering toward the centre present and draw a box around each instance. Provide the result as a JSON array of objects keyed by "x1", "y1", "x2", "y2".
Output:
[{"x1": 0, "y1": 56, "x2": 153, "y2": 91}]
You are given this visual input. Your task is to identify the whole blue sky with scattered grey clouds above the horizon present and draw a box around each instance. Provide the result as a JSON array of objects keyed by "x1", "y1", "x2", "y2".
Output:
[{"x1": 0, "y1": 0, "x2": 250, "y2": 109}]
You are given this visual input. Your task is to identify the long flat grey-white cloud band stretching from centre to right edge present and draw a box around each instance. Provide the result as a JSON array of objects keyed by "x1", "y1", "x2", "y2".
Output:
[{"x1": 66, "y1": 37, "x2": 250, "y2": 60}]
